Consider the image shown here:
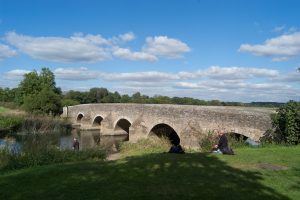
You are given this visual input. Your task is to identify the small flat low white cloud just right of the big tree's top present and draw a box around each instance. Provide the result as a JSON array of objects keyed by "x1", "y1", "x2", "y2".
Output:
[{"x1": 54, "y1": 67, "x2": 101, "y2": 81}]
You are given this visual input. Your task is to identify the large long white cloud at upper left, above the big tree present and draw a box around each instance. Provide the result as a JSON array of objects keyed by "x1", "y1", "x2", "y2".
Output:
[{"x1": 6, "y1": 32, "x2": 110, "y2": 62}]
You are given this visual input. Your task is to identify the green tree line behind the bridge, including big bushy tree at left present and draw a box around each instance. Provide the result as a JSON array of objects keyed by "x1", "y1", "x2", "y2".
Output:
[{"x1": 0, "y1": 68, "x2": 283, "y2": 115}]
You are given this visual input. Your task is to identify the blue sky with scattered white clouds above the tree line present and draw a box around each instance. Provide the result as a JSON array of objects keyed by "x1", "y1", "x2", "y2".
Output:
[{"x1": 0, "y1": 0, "x2": 300, "y2": 102}]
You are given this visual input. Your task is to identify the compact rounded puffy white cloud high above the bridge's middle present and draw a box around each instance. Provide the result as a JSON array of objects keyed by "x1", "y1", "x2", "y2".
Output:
[{"x1": 142, "y1": 36, "x2": 191, "y2": 58}]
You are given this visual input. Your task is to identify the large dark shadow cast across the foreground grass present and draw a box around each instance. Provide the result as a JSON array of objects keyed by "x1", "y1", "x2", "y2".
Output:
[{"x1": 0, "y1": 154, "x2": 289, "y2": 200}]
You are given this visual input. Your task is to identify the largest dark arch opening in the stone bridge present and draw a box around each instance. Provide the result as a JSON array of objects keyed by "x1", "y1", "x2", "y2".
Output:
[{"x1": 148, "y1": 123, "x2": 180, "y2": 145}]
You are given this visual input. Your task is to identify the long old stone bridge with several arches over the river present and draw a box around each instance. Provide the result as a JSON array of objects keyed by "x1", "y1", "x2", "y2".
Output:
[{"x1": 63, "y1": 103, "x2": 274, "y2": 149}]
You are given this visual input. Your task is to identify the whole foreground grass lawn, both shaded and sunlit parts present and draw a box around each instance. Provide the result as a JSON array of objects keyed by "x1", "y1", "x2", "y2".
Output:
[{"x1": 0, "y1": 146, "x2": 300, "y2": 200}]
